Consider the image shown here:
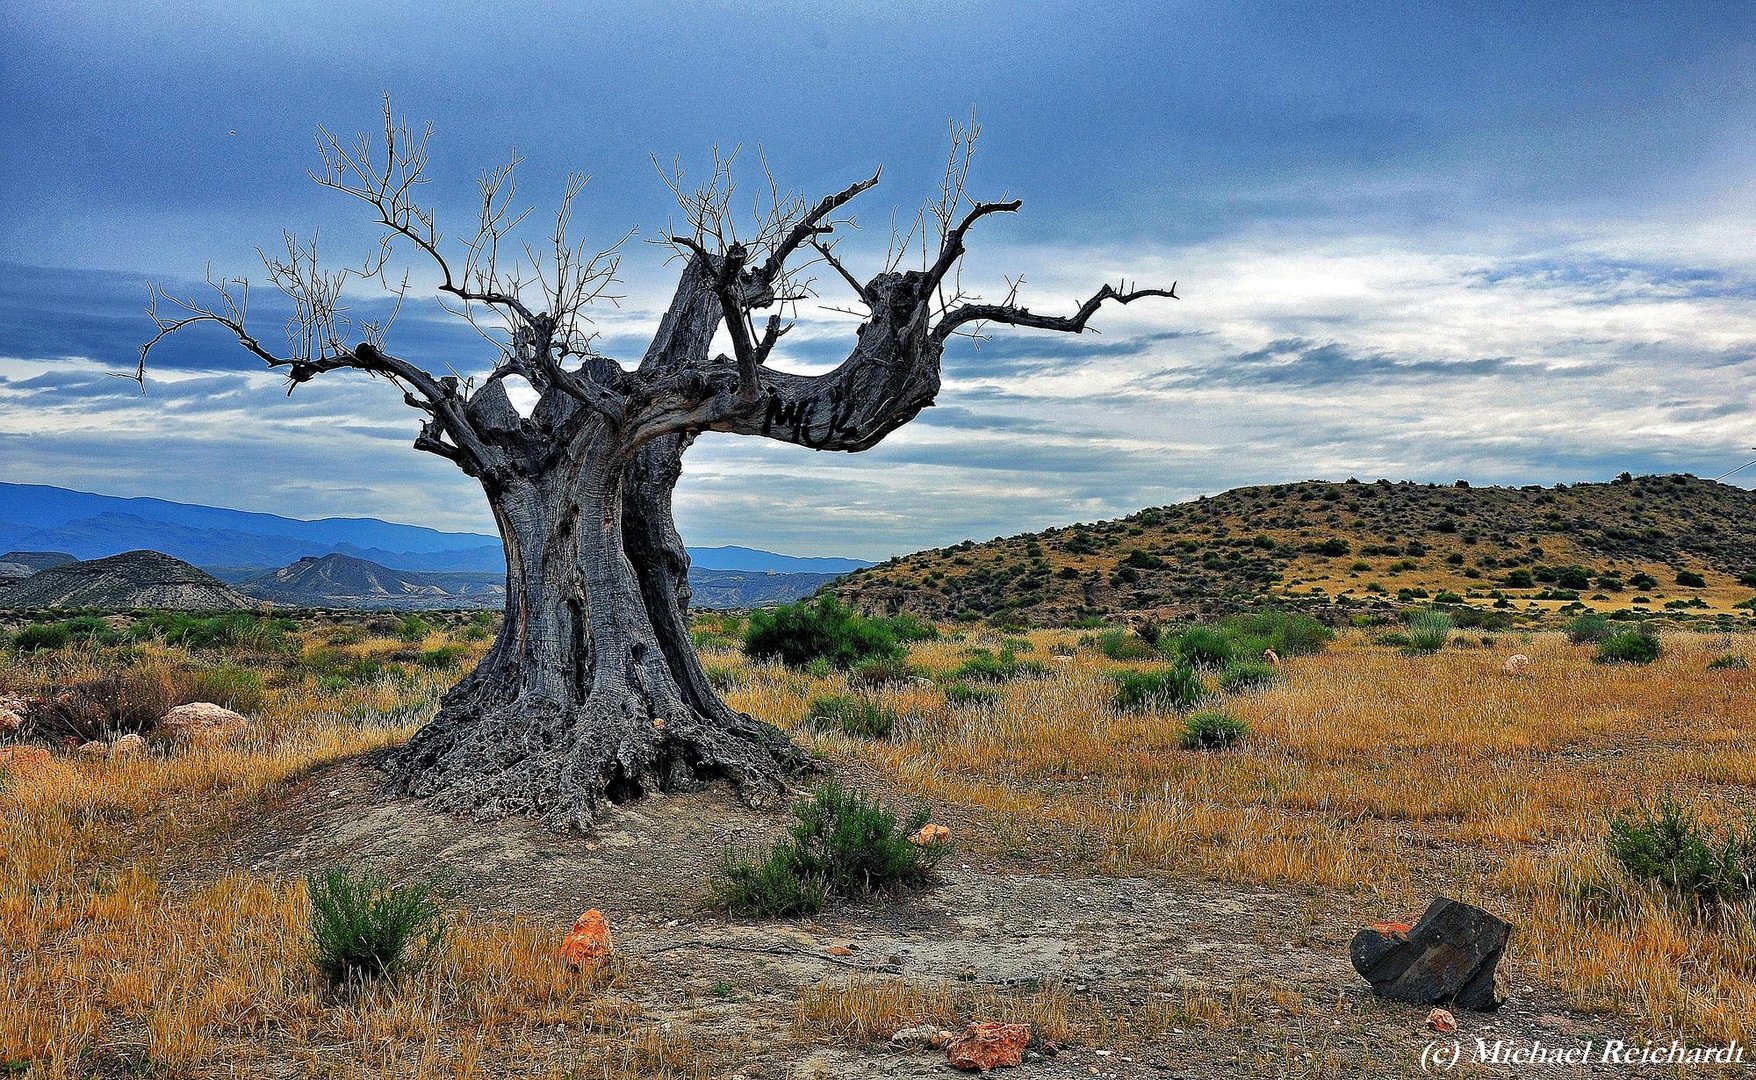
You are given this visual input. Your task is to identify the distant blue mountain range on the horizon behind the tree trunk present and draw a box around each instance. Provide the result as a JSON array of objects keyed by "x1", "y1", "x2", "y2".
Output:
[{"x1": 0, "y1": 483, "x2": 871, "y2": 574}]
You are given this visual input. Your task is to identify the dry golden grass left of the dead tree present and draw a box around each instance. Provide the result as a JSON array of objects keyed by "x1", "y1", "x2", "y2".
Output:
[{"x1": 0, "y1": 634, "x2": 709, "y2": 1078}]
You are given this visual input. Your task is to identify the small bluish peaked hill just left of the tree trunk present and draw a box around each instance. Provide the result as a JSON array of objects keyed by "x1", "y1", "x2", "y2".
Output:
[{"x1": 239, "y1": 555, "x2": 506, "y2": 608}]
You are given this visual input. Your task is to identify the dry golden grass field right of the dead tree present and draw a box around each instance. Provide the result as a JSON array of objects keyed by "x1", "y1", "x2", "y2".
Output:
[{"x1": 716, "y1": 630, "x2": 1756, "y2": 1038}]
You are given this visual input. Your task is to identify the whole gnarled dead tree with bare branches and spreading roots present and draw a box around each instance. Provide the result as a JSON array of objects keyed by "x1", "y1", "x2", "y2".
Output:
[{"x1": 137, "y1": 105, "x2": 1175, "y2": 827}]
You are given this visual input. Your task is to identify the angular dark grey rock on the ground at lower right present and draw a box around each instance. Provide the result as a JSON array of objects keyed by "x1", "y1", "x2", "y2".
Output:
[{"x1": 1349, "y1": 896, "x2": 1512, "y2": 1012}]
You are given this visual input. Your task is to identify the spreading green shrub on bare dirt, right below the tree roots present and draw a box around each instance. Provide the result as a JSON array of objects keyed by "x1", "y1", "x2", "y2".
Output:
[{"x1": 711, "y1": 780, "x2": 950, "y2": 915}]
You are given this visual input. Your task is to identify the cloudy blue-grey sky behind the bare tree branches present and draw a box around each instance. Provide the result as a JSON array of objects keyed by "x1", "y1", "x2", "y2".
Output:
[{"x1": 0, "y1": 0, "x2": 1756, "y2": 558}]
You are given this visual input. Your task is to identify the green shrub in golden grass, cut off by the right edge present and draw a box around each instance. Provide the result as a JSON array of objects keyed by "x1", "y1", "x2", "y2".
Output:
[{"x1": 1605, "y1": 799, "x2": 1756, "y2": 903}]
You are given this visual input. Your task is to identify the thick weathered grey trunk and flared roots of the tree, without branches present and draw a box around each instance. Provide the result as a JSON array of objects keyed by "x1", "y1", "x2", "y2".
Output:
[{"x1": 393, "y1": 419, "x2": 804, "y2": 829}]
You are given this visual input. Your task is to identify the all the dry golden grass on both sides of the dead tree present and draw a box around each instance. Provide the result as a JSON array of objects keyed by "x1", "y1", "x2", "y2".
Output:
[{"x1": 10, "y1": 607, "x2": 1756, "y2": 1076}]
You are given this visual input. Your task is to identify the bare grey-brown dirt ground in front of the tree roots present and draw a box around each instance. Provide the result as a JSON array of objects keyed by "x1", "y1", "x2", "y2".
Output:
[{"x1": 192, "y1": 759, "x2": 1675, "y2": 1080}]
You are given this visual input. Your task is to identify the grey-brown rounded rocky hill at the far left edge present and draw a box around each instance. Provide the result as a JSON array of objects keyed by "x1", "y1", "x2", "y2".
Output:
[{"x1": 0, "y1": 551, "x2": 256, "y2": 611}]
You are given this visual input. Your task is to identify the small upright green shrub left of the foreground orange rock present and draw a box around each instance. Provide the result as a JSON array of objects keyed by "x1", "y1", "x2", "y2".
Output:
[{"x1": 306, "y1": 868, "x2": 444, "y2": 983}]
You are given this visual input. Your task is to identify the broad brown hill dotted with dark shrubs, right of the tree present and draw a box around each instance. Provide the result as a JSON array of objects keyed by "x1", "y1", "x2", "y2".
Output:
[{"x1": 832, "y1": 474, "x2": 1756, "y2": 623}]
